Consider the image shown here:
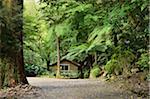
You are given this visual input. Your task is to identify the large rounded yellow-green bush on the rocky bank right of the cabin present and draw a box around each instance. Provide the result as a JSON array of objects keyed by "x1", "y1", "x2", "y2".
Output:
[{"x1": 105, "y1": 50, "x2": 135, "y2": 75}]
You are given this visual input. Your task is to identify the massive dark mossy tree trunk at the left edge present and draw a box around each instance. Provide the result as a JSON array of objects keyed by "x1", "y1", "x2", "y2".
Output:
[{"x1": 0, "y1": 0, "x2": 28, "y2": 88}]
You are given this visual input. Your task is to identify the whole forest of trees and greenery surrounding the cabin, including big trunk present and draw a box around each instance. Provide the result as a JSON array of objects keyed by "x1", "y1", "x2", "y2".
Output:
[{"x1": 0, "y1": 0, "x2": 150, "y2": 97}]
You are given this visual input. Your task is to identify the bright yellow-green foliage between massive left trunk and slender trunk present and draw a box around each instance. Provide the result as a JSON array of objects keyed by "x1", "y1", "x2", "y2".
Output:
[{"x1": 23, "y1": 1, "x2": 56, "y2": 66}]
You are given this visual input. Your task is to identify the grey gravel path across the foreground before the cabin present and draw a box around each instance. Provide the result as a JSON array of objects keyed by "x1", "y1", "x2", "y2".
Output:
[{"x1": 25, "y1": 77, "x2": 141, "y2": 99}]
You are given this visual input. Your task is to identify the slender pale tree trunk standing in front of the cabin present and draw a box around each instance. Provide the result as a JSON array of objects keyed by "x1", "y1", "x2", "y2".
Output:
[{"x1": 56, "y1": 36, "x2": 60, "y2": 78}]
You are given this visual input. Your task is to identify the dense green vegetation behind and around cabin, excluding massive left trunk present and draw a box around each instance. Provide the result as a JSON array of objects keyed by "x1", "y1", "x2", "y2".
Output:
[{"x1": 24, "y1": 0, "x2": 149, "y2": 77}]
